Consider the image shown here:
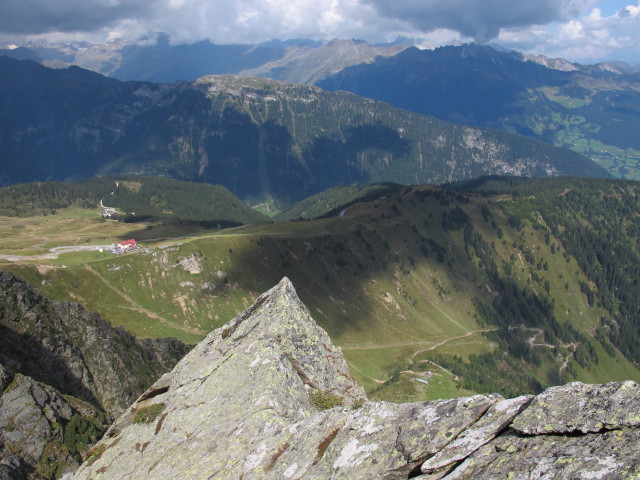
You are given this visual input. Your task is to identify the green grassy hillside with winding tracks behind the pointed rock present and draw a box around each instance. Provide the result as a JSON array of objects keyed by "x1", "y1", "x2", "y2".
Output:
[{"x1": 6, "y1": 179, "x2": 640, "y2": 400}]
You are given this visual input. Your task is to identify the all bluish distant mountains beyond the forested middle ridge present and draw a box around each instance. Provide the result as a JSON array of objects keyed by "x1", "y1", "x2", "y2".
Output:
[{"x1": 3, "y1": 34, "x2": 640, "y2": 179}]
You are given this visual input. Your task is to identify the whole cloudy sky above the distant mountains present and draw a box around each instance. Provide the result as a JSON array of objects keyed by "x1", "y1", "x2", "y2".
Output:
[{"x1": 0, "y1": 0, "x2": 640, "y2": 64}]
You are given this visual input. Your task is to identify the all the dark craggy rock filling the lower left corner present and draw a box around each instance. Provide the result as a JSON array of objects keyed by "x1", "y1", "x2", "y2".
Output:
[{"x1": 0, "y1": 272, "x2": 189, "y2": 479}]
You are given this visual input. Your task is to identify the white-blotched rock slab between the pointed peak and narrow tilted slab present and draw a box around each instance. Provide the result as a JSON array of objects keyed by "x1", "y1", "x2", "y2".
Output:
[{"x1": 253, "y1": 396, "x2": 493, "y2": 480}]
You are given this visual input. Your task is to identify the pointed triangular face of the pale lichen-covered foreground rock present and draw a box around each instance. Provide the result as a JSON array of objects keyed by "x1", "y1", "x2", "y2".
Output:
[{"x1": 69, "y1": 279, "x2": 366, "y2": 479}]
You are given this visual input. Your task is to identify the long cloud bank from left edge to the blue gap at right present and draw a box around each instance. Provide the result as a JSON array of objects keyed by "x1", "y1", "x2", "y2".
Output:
[{"x1": 0, "y1": 0, "x2": 594, "y2": 43}]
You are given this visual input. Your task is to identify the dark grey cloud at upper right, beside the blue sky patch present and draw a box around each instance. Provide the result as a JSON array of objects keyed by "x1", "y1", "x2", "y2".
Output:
[{"x1": 363, "y1": 0, "x2": 594, "y2": 42}]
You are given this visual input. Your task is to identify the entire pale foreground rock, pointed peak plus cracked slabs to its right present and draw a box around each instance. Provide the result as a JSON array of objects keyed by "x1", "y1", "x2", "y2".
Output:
[{"x1": 65, "y1": 278, "x2": 640, "y2": 480}]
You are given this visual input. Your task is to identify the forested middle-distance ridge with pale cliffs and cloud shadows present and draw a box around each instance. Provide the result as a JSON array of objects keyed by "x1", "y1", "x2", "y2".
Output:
[{"x1": 0, "y1": 57, "x2": 608, "y2": 205}]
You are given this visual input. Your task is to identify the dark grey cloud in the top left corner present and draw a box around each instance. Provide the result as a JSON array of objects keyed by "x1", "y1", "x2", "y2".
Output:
[{"x1": 0, "y1": 0, "x2": 163, "y2": 35}]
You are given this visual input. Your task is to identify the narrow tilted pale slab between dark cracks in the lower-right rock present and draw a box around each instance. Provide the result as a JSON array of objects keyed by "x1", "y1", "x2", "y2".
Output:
[{"x1": 421, "y1": 395, "x2": 532, "y2": 478}]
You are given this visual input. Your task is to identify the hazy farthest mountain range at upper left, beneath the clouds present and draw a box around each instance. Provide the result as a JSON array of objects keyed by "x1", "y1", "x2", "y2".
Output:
[{"x1": 0, "y1": 34, "x2": 409, "y2": 83}]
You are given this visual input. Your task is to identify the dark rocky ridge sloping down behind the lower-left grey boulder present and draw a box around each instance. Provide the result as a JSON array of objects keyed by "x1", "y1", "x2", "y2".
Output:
[{"x1": 0, "y1": 272, "x2": 189, "y2": 416}]
